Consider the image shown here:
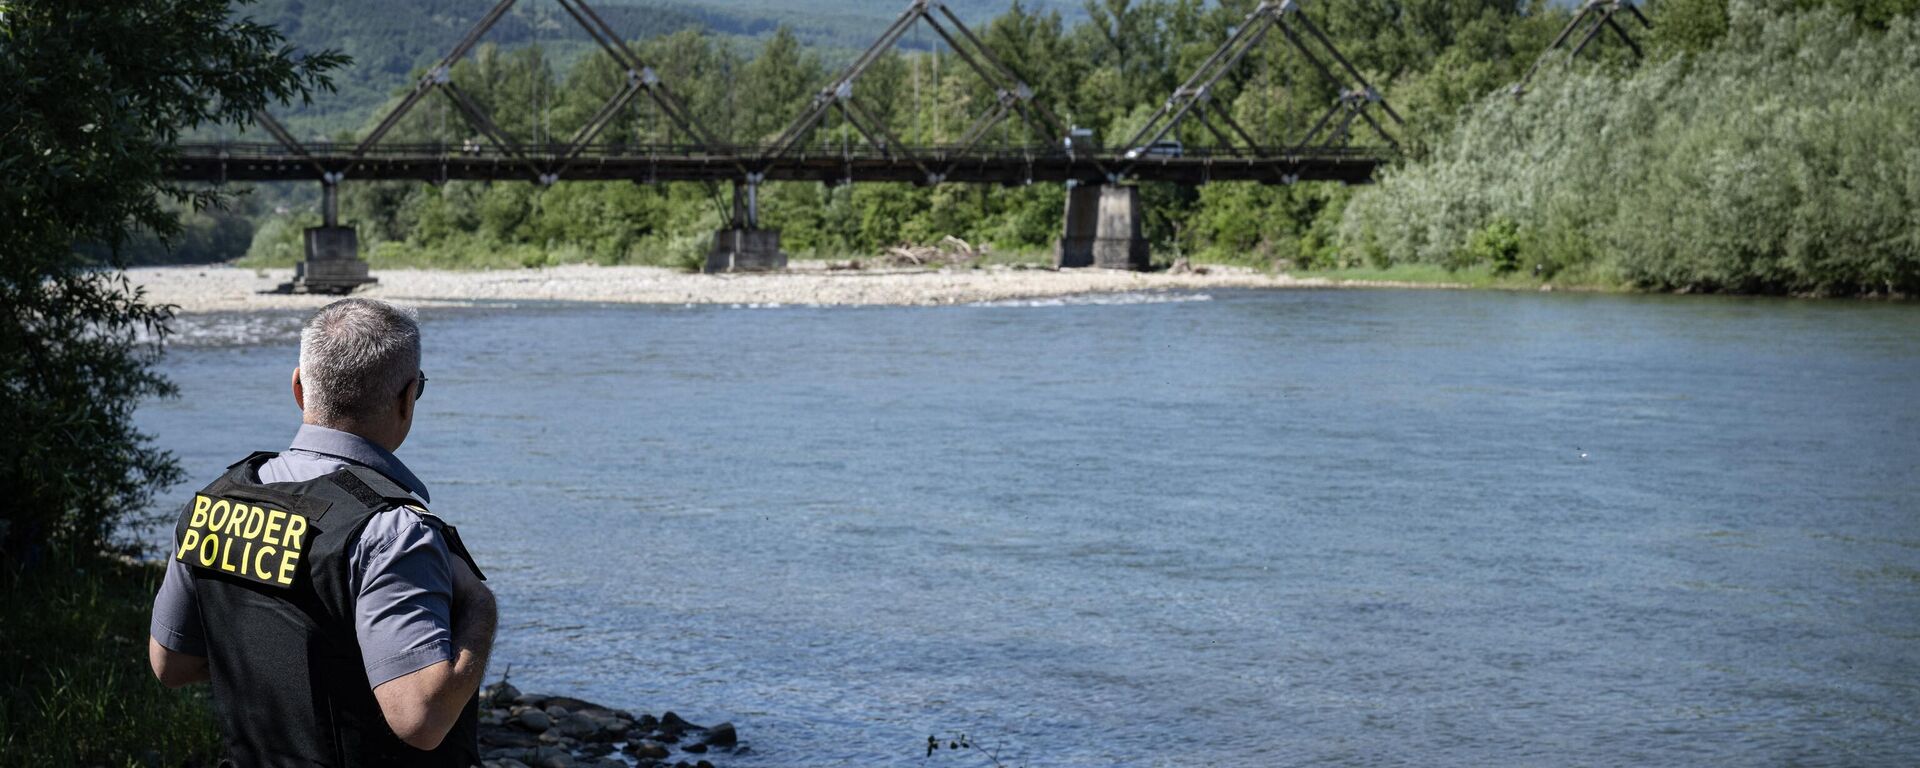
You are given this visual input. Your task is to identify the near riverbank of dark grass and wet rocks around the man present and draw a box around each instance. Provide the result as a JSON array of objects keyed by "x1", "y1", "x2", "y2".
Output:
[{"x1": 0, "y1": 555, "x2": 749, "y2": 768}]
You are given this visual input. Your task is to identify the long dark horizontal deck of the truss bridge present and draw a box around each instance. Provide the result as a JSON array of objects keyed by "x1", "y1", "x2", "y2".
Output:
[{"x1": 169, "y1": 144, "x2": 1390, "y2": 184}]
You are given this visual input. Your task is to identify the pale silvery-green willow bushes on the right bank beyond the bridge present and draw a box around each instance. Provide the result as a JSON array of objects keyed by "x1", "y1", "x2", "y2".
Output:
[{"x1": 1342, "y1": 0, "x2": 1920, "y2": 294}]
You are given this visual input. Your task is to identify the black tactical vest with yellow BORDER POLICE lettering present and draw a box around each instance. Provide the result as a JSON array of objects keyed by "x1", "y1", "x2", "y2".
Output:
[{"x1": 173, "y1": 453, "x2": 480, "y2": 768}]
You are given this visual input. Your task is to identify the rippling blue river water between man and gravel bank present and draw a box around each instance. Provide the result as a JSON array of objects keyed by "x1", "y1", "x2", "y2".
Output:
[{"x1": 138, "y1": 290, "x2": 1920, "y2": 766}]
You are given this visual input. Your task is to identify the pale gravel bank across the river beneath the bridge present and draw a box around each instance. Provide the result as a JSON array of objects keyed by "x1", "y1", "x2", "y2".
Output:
[{"x1": 127, "y1": 261, "x2": 1459, "y2": 313}]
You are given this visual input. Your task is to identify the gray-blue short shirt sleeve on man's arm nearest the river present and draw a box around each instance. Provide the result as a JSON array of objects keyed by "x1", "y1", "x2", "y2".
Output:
[{"x1": 351, "y1": 509, "x2": 453, "y2": 687}]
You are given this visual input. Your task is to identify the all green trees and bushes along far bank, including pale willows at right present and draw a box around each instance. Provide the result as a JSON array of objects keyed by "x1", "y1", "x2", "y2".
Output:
[{"x1": 153, "y1": 0, "x2": 1920, "y2": 294}]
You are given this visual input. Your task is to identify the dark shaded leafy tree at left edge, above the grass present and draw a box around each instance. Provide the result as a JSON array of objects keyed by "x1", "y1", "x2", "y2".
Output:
[{"x1": 0, "y1": 0, "x2": 344, "y2": 564}]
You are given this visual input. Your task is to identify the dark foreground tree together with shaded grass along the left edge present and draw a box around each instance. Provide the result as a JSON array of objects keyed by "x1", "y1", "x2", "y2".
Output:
[{"x1": 0, "y1": 0, "x2": 340, "y2": 766}]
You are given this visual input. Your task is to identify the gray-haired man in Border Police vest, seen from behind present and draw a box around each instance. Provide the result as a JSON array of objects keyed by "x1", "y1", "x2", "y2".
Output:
[{"x1": 148, "y1": 300, "x2": 495, "y2": 768}]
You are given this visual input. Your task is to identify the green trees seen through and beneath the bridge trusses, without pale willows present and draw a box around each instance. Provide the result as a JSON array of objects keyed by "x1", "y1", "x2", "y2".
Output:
[{"x1": 228, "y1": 0, "x2": 1553, "y2": 274}]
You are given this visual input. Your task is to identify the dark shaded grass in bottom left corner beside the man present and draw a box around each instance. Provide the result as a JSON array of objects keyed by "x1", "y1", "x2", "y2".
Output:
[{"x1": 0, "y1": 557, "x2": 219, "y2": 766}]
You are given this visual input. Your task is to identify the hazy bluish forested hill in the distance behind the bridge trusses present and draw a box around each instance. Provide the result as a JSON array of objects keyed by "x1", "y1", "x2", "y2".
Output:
[{"x1": 238, "y1": 0, "x2": 1081, "y2": 136}]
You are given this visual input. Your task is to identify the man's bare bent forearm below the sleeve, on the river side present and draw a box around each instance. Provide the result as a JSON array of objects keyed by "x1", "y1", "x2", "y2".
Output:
[{"x1": 372, "y1": 557, "x2": 497, "y2": 749}]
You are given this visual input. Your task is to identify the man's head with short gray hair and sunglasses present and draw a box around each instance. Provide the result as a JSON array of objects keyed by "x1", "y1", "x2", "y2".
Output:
[{"x1": 294, "y1": 300, "x2": 422, "y2": 451}]
